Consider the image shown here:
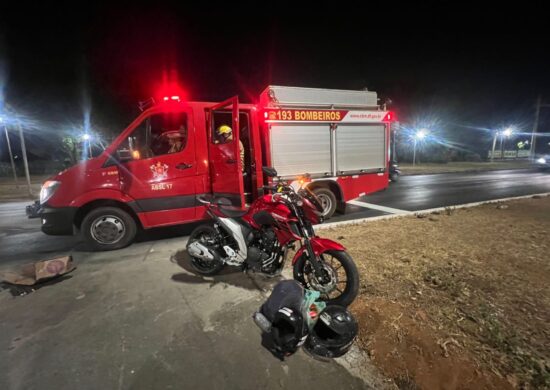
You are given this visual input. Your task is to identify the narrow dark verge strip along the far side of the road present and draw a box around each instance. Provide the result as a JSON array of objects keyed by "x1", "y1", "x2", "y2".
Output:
[{"x1": 399, "y1": 160, "x2": 532, "y2": 175}]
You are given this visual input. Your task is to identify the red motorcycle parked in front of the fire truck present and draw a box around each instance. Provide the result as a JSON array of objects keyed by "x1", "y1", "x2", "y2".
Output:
[{"x1": 187, "y1": 167, "x2": 359, "y2": 306}]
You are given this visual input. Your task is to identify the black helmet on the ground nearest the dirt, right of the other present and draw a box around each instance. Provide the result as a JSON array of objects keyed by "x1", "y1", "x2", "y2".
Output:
[{"x1": 304, "y1": 305, "x2": 359, "y2": 358}]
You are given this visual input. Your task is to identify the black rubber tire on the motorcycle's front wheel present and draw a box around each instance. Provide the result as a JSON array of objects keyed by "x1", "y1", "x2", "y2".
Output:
[{"x1": 293, "y1": 251, "x2": 359, "y2": 307}]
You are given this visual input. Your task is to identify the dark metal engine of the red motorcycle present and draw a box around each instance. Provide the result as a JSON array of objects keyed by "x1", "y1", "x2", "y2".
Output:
[{"x1": 250, "y1": 228, "x2": 282, "y2": 274}]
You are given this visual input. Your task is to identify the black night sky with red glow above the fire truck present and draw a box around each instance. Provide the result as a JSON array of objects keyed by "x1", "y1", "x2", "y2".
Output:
[{"x1": 0, "y1": 2, "x2": 550, "y2": 158}]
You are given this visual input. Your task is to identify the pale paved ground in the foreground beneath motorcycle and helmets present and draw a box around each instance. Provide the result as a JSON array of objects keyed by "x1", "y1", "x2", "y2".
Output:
[{"x1": 0, "y1": 229, "x2": 389, "y2": 390}]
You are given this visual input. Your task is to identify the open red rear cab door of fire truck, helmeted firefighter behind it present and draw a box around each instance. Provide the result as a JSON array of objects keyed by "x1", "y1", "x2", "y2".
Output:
[{"x1": 208, "y1": 96, "x2": 245, "y2": 207}]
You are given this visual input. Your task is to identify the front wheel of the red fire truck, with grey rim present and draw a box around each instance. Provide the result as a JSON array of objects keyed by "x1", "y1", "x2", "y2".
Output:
[{"x1": 80, "y1": 207, "x2": 137, "y2": 251}]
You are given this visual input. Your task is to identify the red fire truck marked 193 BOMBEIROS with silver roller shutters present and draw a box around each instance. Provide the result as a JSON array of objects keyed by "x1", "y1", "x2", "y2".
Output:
[{"x1": 27, "y1": 86, "x2": 393, "y2": 250}]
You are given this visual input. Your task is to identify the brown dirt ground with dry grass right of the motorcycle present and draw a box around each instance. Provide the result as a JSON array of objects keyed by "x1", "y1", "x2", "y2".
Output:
[{"x1": 319, "y1": 197, "x2": 550, "y2": 389}]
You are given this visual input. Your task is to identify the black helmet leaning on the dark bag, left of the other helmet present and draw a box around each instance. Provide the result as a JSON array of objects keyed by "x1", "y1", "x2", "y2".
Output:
[{"x1": 271, "y1": 307, "x2": 307, "y2": 358}]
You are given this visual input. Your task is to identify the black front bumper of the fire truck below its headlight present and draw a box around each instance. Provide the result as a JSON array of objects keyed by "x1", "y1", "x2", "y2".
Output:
[{"x1": 25, "y1": 202, "x2": 77, "y2": 236}]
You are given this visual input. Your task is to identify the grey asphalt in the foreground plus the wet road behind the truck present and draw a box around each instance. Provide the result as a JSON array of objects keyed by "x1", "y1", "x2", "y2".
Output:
[{"x1": 0, "y1": 170, "x2": 550, "y2": 389}]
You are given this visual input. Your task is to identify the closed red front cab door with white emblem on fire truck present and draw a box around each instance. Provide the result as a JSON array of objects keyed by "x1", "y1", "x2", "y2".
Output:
[{"x1": 117, "y1": 112, "x2": 197, "y2": 226}]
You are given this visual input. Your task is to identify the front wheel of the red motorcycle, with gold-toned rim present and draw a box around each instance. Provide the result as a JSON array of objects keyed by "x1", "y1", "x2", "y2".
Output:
[{"x1": 293, "y1": 251, "x2": 359, "y2": 307}]
